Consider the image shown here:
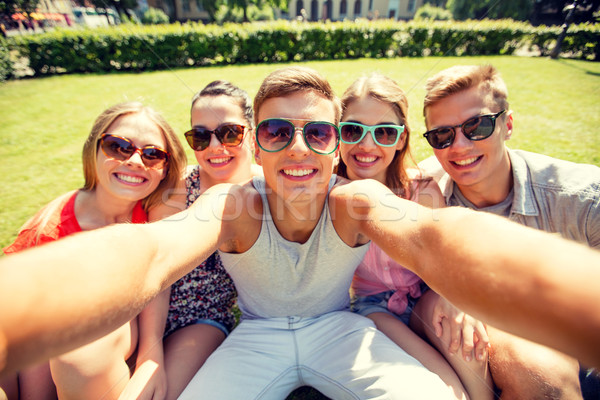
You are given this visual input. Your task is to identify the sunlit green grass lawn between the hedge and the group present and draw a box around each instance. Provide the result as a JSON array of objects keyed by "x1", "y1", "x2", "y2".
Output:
[{"x1": 0, "y1": 57, "x2": 600, "y2": 247}]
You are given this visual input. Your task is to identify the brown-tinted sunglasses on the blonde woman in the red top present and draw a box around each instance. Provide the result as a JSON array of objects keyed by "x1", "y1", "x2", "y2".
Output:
[{"x1": 98, "y1": 133, "x2": 169, "y2": 169}]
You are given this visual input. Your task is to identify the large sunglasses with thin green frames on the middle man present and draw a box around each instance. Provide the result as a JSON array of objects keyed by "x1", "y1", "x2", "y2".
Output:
[{"x1": 256, "y1": 118, "x2": 340, "y2": 155}]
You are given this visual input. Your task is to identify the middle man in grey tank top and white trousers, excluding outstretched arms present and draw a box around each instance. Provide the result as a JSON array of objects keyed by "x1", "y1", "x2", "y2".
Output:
[{"x1": 180, "y1": 68, "x2": 456, "y2": 400}]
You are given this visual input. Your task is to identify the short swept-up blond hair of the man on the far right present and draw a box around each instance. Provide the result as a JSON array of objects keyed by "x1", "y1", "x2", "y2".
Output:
[{"x1": 423, "y1": 65, "x2": 509, "y2": 117}]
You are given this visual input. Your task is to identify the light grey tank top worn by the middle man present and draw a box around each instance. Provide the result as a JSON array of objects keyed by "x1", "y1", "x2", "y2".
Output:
[{"x1": 219, "y1": 175, "x2": 369, "y2": 319}]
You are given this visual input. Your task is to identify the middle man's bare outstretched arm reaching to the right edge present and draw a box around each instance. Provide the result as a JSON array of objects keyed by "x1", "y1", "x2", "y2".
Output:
[{"x1": 336, "y1": 181, "x2": 600, "y2": 366}]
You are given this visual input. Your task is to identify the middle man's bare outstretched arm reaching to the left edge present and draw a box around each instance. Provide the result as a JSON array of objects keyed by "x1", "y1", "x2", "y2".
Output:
[{"x1": 0, "y1": 185, "x2": 244, "y2": 375}]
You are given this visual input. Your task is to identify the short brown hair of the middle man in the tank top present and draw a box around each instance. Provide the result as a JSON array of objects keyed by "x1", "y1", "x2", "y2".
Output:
[{"x1": 254, "y1": 67, "x2": 342, "y2": 124}]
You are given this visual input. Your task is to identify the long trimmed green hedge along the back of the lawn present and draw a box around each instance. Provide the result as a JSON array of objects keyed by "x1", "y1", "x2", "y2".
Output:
[{"x1": 5, "y1": 20, "x2": 600, "y2": 75}]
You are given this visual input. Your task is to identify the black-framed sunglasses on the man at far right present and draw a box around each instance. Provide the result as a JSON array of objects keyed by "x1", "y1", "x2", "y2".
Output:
[{"x1": 423, "y1": 110, "x2": 506, "y2": 149}]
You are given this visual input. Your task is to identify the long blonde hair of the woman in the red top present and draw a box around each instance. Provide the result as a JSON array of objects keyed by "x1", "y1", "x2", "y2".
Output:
[{"x1": 82, "y1": 102, "x2": 187, "y2": 211}]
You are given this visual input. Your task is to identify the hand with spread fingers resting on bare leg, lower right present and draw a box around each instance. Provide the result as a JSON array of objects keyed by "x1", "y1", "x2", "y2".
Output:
[{"x1": 432, "y1": 296, "x2": 489, "y2": 361}]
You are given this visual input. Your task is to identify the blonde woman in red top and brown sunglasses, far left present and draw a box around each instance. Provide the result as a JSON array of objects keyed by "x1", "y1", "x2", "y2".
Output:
[{"x1": 0, "y1": 102, "x2": 185, "y2": 399}]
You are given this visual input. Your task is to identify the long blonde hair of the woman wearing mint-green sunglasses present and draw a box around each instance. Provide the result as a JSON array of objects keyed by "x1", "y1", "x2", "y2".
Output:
[{"x1": 337, "y1": 74, "x2": 411, "y2": 198}]
